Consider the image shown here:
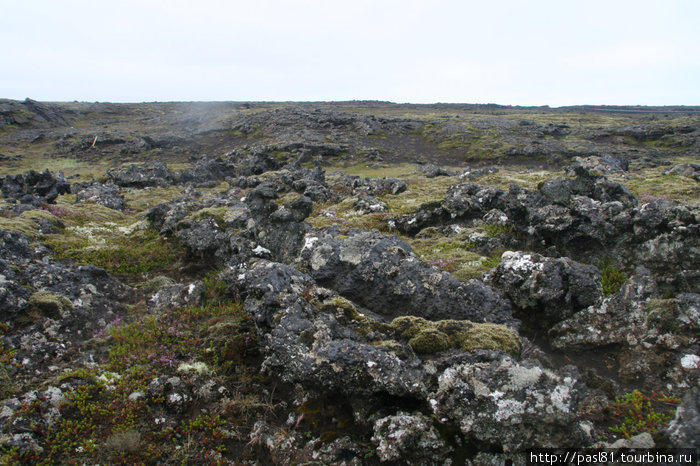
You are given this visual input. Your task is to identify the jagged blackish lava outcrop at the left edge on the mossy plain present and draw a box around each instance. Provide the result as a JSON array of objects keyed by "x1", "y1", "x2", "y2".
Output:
[{"x1": 0, "y1": 170, "x2": 71, "y2": 207}]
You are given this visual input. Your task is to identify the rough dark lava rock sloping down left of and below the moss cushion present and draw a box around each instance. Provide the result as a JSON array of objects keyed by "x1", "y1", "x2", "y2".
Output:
[{"x1": 221, "y1": 260, "x2": 426, "y2": 397}]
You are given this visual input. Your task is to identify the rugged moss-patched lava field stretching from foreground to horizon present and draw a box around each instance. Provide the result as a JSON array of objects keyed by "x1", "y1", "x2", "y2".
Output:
[{"x1": 0, "y1": 100, "x2": 700, "y2": 465}]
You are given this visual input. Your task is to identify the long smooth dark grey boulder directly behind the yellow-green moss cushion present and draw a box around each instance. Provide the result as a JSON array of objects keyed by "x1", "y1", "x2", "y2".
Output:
[{"x1": 300, "y1": 232, "x2": 517, "y2": 326}]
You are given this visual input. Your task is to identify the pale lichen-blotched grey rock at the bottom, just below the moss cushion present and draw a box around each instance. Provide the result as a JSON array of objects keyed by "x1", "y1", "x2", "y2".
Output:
[{"x1": 429, "y1": 357, "x2": 593, "y2": 452}]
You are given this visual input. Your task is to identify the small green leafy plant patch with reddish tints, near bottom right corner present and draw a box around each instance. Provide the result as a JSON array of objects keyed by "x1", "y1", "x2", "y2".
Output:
[{"x1": 608, "y1": 390, "x2": 680, "y2": 438}]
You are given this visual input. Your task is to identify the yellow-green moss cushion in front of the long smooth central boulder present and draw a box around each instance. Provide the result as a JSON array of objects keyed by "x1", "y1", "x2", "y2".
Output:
[{"x1": 391, "y1": 316, "x2": 520, "y2": 355}]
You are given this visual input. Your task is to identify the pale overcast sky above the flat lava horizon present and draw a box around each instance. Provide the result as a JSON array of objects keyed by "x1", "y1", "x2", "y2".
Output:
[{"x1": 0, "y1": 0, "x2": 700, "y2": 107}]
